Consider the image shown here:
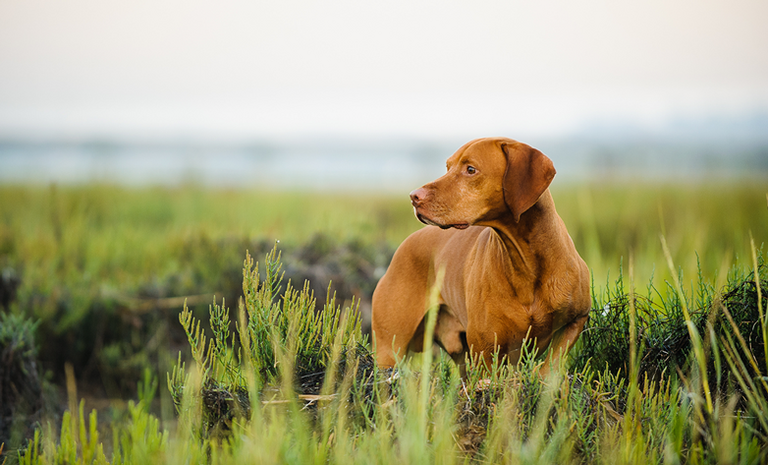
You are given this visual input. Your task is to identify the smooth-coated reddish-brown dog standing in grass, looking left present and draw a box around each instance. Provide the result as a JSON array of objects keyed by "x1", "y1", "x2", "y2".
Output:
[{"x1": 372, "y1": 138, "x2": 591, "y2": 367}]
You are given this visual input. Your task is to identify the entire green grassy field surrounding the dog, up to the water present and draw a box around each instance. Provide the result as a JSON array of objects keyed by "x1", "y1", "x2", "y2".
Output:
[{"x1": 0, "y1": 181, "x2": 768, "y2": 463}]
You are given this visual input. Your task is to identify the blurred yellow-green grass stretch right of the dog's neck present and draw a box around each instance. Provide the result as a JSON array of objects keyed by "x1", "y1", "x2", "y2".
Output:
[{"x1": 553, "y1": 182, "x2": 768, "y2": 285}]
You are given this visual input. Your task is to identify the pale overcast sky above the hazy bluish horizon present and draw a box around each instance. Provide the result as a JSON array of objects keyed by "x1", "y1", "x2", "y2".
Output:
[{"x1": 0, "y1": 0, "x2": 768, "y2": 139}]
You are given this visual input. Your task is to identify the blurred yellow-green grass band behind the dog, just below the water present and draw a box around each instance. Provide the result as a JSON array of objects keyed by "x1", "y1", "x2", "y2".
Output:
[{"x1": 0, "y1": 183, "x2": 768, "y2": 293}]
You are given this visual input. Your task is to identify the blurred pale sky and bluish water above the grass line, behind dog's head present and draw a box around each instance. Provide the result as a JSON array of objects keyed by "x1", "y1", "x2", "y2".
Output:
[{"x1": 0, "y1": 0, "x2": 768, "y2": 187}]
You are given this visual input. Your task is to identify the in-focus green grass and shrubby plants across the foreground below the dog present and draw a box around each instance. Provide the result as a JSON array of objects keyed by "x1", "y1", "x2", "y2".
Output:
[{"x1": 13, "y1": 241, "x2": 768, "y2": 464}]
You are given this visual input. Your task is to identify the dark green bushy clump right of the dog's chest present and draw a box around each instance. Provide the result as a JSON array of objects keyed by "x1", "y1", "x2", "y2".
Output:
[{"x1": 571, "y1": 255, "x2": 768, "y2": 385}]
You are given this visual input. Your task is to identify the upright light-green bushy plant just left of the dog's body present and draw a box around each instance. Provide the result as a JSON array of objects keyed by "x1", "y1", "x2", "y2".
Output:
[{"x1": 168, "y1": 246, "x2": 373, "y2": 436}]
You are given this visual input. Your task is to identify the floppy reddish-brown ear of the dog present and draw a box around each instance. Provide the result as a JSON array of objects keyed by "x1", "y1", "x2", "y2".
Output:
[{"x1": 501, "y1": 142, "x2": 555, "y2": 222}]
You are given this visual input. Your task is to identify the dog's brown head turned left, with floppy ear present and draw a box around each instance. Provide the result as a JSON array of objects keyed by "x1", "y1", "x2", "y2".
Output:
[{"x1": 411, "y1": 138, "x2": 555, "y2": 229}]
